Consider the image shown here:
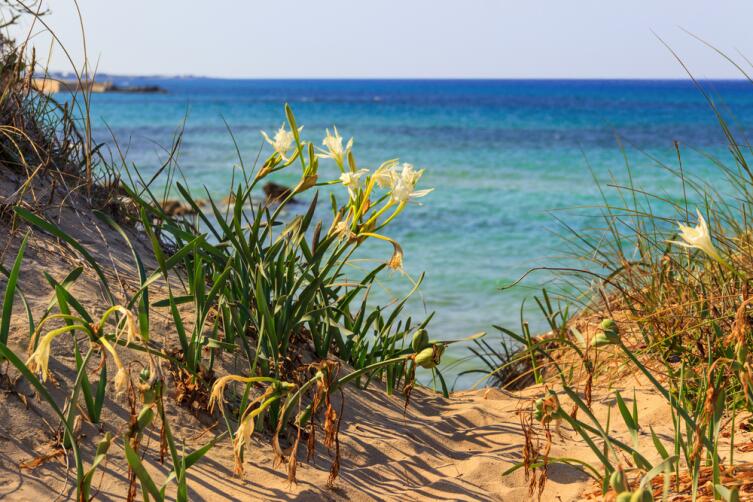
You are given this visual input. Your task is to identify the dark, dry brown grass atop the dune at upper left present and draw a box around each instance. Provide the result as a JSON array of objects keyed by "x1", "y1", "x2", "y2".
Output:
[{"x1": 0, "y1": 0, "x2": 135, "y2": 257}]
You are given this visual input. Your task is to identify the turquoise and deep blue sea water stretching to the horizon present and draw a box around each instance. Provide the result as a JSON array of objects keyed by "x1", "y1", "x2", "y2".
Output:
[{"x1": 85, "y1": 78, "x2": 753, "y2": 384}]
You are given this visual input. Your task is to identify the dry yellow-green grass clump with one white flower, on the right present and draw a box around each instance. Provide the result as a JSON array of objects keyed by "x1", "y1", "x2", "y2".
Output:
[{"x1": 480, "y1": 52, "x2": 753, "y2": 500}]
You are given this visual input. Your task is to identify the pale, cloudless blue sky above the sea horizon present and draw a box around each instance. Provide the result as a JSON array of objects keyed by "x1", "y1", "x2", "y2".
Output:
[{"x1": 8, "y1": 0, "x2": 753, "y2": 78}]
